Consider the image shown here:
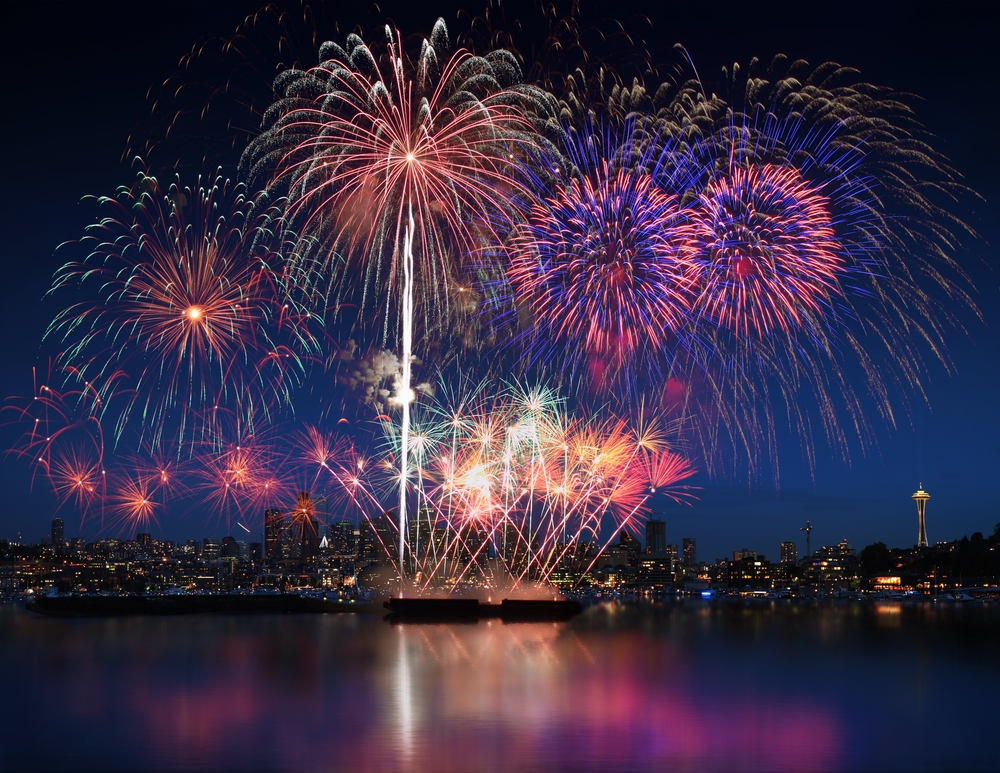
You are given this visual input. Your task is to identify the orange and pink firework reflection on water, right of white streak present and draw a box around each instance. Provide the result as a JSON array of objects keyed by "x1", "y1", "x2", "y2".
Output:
[{"x1": 386, "y1": 623, "x2": 841, "y2": 770}]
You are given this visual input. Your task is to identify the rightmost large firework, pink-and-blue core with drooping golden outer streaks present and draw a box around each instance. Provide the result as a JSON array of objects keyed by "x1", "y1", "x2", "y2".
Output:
[{"x1": 643, "y1": 57, "x2": 975, "y2": 478}]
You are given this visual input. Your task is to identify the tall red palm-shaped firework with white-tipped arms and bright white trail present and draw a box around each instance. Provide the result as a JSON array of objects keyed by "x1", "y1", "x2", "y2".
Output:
[{"x1": 243, "y1": 20, "x2": 552, "y2": 572}]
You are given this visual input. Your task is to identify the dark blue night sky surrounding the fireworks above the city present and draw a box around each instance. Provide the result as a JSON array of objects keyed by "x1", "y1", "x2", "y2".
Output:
[{"x1": 0, "y1": 2, "x2": 1000, "y2": 560}]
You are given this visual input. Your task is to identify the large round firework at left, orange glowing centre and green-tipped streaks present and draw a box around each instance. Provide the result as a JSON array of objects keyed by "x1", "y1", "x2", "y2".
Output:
[{"x1": 46, "y1": 174, "x2": 318, "y2": 449}]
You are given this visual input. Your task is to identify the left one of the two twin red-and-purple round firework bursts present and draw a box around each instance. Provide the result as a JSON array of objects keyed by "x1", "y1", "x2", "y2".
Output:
[{"x1": 500, "y1": 127, "x2": 698, "y2": 390}]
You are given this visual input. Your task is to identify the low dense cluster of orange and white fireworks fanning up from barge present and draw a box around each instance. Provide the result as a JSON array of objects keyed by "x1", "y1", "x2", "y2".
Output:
[{"x1": 376, "y1": 384, "x2": 694, "y2": 587}]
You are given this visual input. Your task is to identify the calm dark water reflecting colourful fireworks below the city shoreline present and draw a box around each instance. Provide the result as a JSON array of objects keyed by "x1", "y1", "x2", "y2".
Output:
[{"x1": 0, "y1": 602, "x2": 1000, "y2": 771}]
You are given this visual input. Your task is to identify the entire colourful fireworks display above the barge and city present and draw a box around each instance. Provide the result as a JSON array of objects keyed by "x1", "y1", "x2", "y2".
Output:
[{"x1": 5, "y1": 7, "x2": 975, "y2": 589}]
